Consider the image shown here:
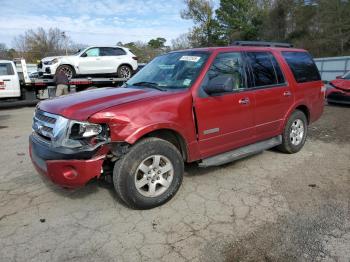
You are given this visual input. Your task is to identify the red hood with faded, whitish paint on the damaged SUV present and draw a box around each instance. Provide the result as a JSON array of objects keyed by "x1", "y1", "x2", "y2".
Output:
[{"x1": 39, "y1": 87, "x2": 168, "y2": 121}]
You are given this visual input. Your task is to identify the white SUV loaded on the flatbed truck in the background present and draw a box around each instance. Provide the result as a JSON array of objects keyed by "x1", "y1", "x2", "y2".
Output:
[{"x1": 38, "y1": 46, "x2": 137, "y2": 78}]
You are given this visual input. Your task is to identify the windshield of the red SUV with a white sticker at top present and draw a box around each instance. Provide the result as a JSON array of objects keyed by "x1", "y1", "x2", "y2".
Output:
[{"x1": 126, "y1": 51, "x2": 209, "y2": 90}]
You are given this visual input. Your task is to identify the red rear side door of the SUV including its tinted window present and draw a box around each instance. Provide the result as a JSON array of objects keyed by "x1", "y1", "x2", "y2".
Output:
[{"x1": 246, "y1": 51, "x2": 294, "y2": 140}]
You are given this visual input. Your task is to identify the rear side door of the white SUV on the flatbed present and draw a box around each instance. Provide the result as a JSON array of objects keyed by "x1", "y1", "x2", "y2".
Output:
[{"x1": 100, "y1": 47, "x2": 126, "y2": 73}]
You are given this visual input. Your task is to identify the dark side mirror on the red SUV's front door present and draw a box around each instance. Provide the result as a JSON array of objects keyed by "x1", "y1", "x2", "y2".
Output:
[{"x1": 203, "y1": 75, "x2": 234, "y2": 95}]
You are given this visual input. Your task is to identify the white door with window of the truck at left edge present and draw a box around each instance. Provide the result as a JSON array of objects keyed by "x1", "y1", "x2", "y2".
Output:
[{"x1": 0, "y1": 62, "x2": 21, "y2": 98}]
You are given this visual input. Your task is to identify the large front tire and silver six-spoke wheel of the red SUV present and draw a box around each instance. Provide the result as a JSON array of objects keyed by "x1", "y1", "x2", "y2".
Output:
[{"x1": 113, "y1": 138, "x2": 184, "y2": 209}]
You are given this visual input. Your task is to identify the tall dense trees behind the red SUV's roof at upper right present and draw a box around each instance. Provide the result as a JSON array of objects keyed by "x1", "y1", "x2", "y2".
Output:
[{"x1": 181, "y1": 0, "x2": 350, "y2": 57}]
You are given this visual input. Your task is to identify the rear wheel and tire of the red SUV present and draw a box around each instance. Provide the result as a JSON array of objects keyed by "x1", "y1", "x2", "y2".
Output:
[{"x1": 277, "y1": 110, "x2": 307, "y2": 154}]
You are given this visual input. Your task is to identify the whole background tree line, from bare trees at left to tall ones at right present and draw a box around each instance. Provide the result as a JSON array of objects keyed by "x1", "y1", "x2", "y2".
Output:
[{"x1": 0, "y1": 0, "x2": 350, "y2": 63}]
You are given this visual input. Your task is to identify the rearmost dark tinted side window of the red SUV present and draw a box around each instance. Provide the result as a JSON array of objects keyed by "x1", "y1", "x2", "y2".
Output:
[{"x1": 282, "y1": 52, "x2": 321, "y2": 83}]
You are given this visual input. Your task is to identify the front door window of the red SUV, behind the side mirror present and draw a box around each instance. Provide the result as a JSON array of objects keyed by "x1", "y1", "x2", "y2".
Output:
[{"x1": 202, "y1": 52, "x2": 246, "y2": 91}]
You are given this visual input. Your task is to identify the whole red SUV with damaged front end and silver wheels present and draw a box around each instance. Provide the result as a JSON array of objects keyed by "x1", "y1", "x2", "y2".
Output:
[{"x1": 30, "y1": 42, "x2": 325, "y2": 209}]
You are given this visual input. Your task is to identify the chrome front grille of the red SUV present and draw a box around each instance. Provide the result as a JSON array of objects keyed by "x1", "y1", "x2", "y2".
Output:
[{"x1": 33, "y1": 109, "x2": 59, "y2": 141}]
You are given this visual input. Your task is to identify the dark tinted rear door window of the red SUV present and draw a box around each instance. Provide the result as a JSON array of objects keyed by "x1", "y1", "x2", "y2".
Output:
[{"x1": 247, "y1": 52, "x2": 285, "y2": 87}]
